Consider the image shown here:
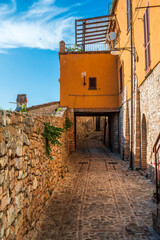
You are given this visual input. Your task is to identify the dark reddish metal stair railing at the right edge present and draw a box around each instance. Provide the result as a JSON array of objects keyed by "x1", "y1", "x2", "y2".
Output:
[{"x1": 153, "y1": 133, "x2": 160, "y2": 204}]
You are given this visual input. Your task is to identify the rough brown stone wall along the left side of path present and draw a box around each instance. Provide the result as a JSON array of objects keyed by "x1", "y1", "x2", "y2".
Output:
[{"x1": 0, "y1": 111, "x2": 69, "y2": 240}]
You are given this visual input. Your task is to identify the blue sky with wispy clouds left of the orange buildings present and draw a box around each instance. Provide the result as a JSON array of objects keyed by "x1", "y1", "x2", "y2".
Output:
[{"x1": 0, "y1": 0, "x2": 111, "y2": 109}]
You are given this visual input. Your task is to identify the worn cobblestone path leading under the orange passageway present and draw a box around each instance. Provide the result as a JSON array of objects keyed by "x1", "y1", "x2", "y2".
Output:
[{"x1": 31, "y1": 141, "x2": 160, "y2": 240}]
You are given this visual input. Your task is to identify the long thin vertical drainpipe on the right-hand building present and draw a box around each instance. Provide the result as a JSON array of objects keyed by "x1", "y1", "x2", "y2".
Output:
[{"x1": 130, "y1": 0, "x2": 133, "y2": 170}]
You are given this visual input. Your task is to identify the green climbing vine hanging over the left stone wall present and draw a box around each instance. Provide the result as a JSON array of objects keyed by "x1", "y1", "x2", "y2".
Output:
[{"x1": 42, "y1": 122, "x2": 64, "y2": 159}]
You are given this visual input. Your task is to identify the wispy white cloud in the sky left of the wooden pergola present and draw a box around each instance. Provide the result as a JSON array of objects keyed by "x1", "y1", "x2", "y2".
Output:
[{"x1": 0, "y1": 0, "x2": 74, "y2": 52}]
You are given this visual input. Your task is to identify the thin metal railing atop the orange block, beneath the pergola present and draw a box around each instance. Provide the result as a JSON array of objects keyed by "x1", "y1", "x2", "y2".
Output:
[{"x1": 65, "y1": 43, "x2": 108, "y2": 52}]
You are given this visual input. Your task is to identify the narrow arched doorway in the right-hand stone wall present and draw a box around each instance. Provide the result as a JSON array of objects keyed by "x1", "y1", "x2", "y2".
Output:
[{"x1": 141, "y1": 114, "x2": 147, "y2": 170}]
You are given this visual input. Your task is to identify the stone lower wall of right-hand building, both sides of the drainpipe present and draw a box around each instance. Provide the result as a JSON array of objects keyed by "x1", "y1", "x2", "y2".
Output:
[{"x1": 119, "y1": 63, "x2": 160, "y2": 178}]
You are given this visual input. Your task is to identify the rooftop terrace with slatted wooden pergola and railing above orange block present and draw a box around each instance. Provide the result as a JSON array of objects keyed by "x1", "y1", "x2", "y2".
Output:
[{"x1": 60, "y1": 15, "x2": 116, "y2": 53}]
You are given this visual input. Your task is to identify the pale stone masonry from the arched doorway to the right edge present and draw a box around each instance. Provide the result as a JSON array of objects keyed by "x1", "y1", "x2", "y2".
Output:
[{"x1": 139, "y1": 63, "x2": 160, "y2": 175}]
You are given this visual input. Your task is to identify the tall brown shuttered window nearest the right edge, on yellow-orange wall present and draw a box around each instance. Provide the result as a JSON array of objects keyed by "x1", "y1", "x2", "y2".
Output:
[{"x1": 143, "y1": 8, "x2": 151, "y2": 72}]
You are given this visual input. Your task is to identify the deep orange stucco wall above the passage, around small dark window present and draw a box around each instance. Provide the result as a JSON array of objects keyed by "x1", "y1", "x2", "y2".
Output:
[{"x1": 59, "y1": 52, "x2": 119, "y2": 108}]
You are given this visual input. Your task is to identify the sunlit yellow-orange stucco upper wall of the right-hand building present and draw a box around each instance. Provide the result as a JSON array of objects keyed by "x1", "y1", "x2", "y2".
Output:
[{"x1": 114, "y1": 0, "x2": 160, "y2": 101}]
